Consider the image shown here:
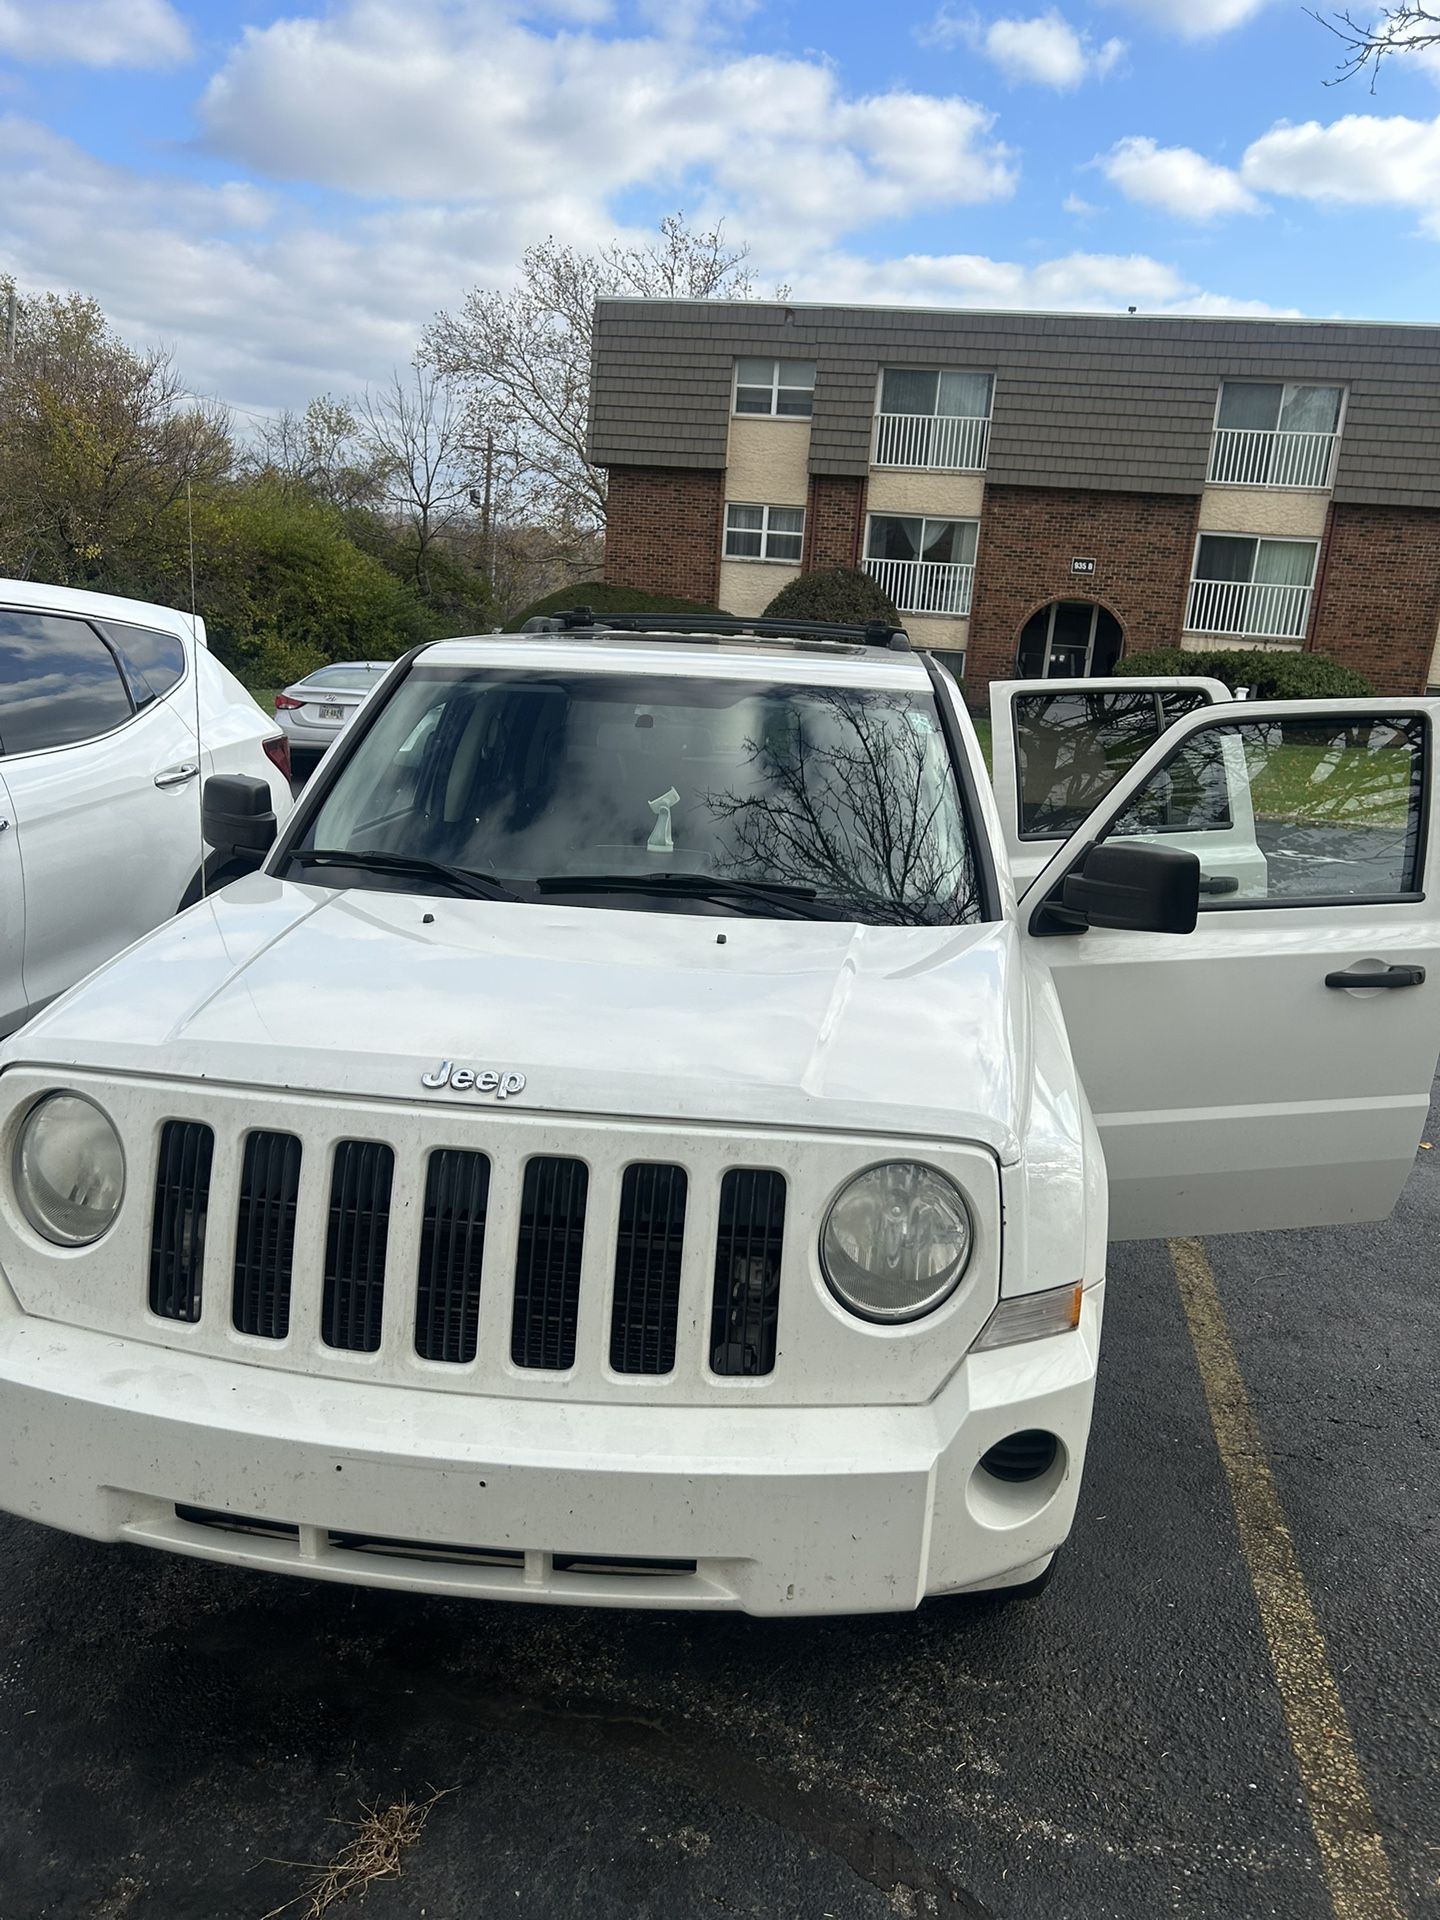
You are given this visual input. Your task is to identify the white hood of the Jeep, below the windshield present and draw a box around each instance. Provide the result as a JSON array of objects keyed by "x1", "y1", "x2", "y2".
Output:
[{"x1": 0, "y1": 876, "x2": 1031, "y2": 1160}]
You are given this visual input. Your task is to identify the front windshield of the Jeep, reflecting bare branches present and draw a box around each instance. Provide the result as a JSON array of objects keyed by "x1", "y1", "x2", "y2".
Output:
[{"x1": 292, "y1": 666, "x2": 981, "y2": 925}]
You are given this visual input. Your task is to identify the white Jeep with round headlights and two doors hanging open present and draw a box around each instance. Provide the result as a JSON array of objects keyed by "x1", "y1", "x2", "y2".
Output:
[{"x1": 0, "y1": 616, "x2": 1440, "y2": 1615}]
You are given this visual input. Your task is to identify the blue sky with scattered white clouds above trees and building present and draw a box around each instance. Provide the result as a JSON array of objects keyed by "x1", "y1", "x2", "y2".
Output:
[{"x1": 0, "y1": 0, "x2": 1440, "y2": 413}]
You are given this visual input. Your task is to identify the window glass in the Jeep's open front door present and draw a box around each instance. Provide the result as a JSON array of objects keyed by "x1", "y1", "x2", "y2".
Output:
[{"x1": 1104, "y1": 714, "x2": 1427, "y2": 910}]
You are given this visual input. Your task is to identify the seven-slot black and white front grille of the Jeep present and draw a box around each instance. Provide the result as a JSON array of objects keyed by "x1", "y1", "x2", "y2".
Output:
[{"x1": 150, "y1": 1121, "x2": 785, "y2": 1377}]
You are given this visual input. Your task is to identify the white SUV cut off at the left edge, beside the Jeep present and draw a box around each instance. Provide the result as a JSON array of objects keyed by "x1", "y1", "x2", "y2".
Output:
[{"x1": 0, "y1": 580, "x2": 290, "y2": 1033}]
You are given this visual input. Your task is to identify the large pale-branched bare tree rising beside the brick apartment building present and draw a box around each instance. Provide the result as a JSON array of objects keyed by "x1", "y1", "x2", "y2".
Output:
[{"x1": 422, "y1": 213, "x2": 779, "y2": 545}]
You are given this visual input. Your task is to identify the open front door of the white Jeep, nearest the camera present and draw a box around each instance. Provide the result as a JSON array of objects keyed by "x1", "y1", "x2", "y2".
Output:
[{"x1": 1021, "y1": 699, "x2": 1440, "y2": 1238}]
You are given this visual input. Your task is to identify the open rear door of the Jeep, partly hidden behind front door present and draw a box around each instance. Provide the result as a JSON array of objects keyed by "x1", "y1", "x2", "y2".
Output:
[{"x1": 991, "y1": 676, "x2": 1231, "y2": 889}]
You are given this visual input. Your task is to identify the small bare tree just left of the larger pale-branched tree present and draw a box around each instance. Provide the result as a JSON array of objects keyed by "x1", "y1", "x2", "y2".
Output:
[{"x1": 359, "y1": 365, "x2": 470, "y2": 593}]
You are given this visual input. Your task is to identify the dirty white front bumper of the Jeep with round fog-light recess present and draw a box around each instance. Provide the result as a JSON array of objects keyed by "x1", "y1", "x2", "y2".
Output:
[{"x1": 0, "y1": 1284, "x2": 1104, "y2": 1615}]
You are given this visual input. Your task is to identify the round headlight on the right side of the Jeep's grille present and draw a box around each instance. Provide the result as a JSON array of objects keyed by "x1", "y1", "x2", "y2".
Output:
[{"x1": 820, "y1": 1160, "x2": 972, "y2": 1321}]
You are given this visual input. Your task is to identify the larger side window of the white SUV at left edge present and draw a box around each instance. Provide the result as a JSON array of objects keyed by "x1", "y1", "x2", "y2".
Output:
[{"x1": 0, "y1": 611, "x2": 134, "y2": 755}]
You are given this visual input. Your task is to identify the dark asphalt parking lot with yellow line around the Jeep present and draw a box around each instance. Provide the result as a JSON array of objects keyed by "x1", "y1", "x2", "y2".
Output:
[{"x1": 0, "y1": 1082, "x2": 1440, "y2": 1920}]
